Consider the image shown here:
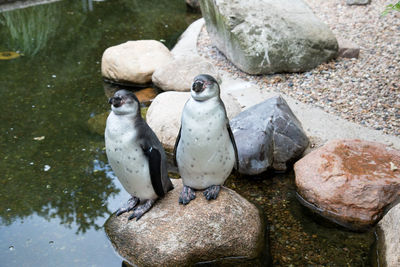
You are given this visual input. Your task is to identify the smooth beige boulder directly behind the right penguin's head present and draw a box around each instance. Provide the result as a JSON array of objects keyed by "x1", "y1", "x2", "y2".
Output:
[{"x1": 152, "y1": 55, "x2": 220, "y2": 92}]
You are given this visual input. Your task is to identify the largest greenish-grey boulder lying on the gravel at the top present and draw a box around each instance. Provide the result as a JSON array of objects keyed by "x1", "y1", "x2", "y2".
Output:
[{"x1": 200, "y1": 0, "x2": 338, "y2": 74}]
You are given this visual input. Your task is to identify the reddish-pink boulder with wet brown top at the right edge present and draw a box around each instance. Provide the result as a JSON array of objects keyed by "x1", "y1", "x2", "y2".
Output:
[{"x1": 294, "y1": 140, "x2": 400, "y2": 230}]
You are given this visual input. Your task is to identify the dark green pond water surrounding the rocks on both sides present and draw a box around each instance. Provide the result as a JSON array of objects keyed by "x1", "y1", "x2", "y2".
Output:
[{"x1": 0, "y1": 0, "x2": 374, "y2": 266}]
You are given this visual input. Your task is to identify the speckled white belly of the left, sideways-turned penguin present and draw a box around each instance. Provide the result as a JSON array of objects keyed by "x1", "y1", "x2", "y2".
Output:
[{"x1": 105, "y1": 113, "x2": 157, "y2": 199}]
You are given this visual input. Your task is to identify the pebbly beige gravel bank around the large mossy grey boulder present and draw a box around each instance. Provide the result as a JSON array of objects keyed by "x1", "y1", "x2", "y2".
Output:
[{"x1": 197, "y1": 0, "x2": 400, "y2": 136}]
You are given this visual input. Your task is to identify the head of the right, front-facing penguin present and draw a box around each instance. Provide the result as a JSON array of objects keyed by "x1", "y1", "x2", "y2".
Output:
[{"x1": 190, "y1": 74, "x2": 220, "y2": 101}]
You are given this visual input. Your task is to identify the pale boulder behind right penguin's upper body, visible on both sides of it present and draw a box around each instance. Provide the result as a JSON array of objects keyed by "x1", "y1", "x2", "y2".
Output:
[{"x1": 146, "y1": 92, "x2": 241, "y2": 150}]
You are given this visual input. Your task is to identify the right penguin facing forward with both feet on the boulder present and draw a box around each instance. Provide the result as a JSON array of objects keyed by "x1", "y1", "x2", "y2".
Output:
[{"x1": 174, "y1": 74, "x2": 239, "y2": 205}]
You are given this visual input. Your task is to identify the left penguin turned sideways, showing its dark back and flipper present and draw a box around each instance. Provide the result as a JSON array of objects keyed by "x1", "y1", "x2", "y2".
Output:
[{"x1": 104, "y1": 90, "x2": 173, "y2": 220}]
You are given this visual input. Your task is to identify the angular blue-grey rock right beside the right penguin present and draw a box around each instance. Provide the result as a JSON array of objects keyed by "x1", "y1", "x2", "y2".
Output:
[{"x1": 230, "y1": 96, "x2": 309, "y2": 175}]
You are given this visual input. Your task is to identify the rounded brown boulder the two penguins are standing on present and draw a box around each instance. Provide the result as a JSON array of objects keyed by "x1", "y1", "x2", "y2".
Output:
[{"x1": 105, "y1": 179, "x2": 267, "y2": 266}]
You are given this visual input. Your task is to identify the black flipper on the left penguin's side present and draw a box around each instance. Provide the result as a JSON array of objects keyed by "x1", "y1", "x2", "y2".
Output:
[{"x1": 142, "y1": 147, "x2": 165, "y2": 197}]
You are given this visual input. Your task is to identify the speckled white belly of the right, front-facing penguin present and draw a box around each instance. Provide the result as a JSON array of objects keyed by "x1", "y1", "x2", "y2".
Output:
[{"x1": 176, "y1": 99, "x2": 235, "y2": 189}]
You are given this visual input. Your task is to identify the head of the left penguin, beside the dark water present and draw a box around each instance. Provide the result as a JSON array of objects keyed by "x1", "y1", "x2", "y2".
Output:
[{"x1": 108, "y1": 90, "x2": 140, "y2": 116}]
